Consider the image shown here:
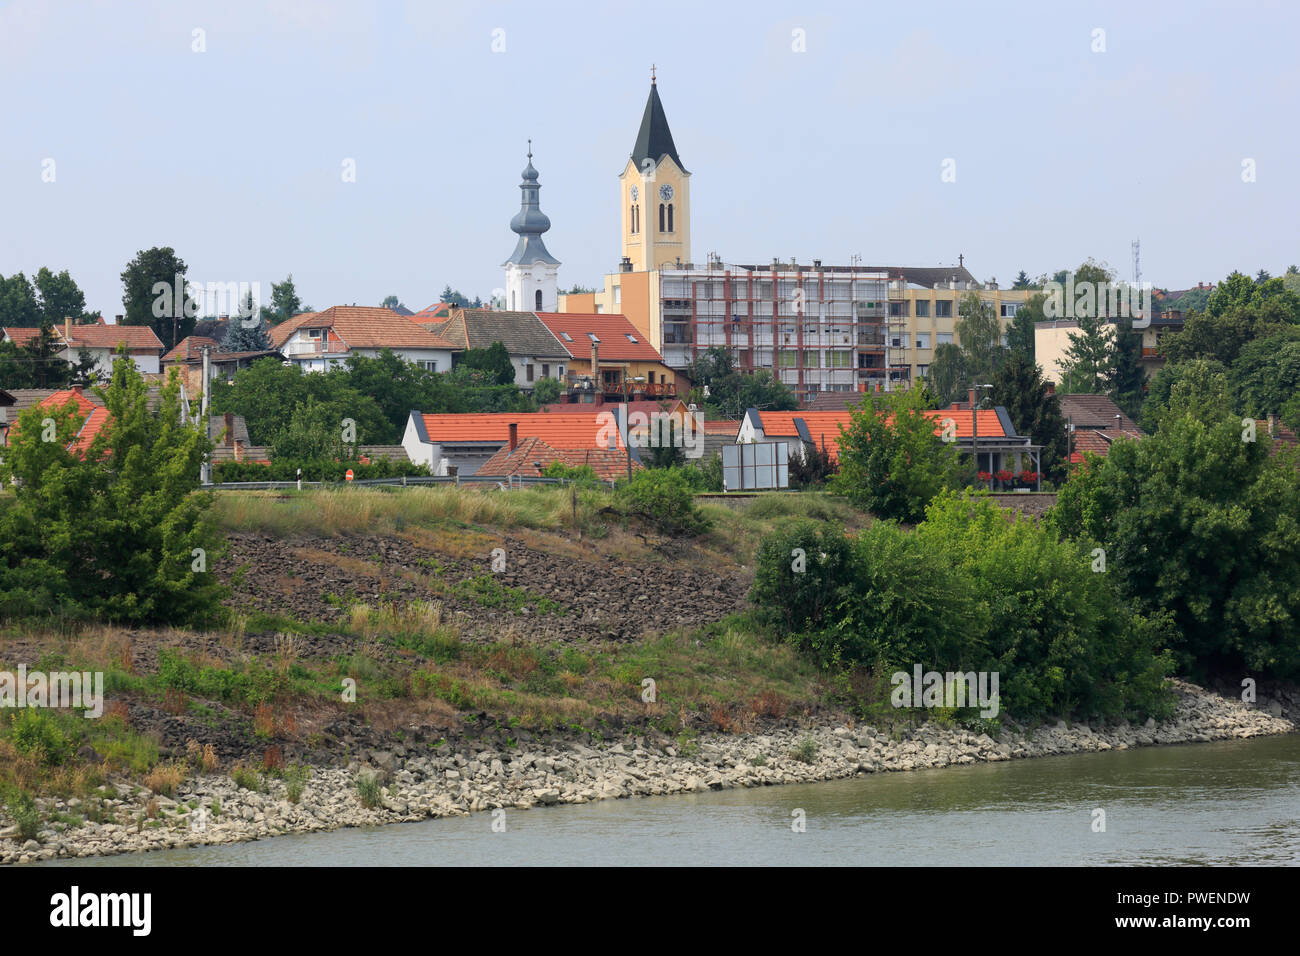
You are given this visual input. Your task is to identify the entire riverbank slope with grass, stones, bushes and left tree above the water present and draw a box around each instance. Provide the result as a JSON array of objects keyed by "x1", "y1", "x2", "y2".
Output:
[{"x1": 0, "y1": 363, "x2": 1294, "y2": 861}]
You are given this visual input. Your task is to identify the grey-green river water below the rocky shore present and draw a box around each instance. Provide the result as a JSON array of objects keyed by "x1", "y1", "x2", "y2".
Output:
[{"x1": 47, "y1": 734, "x2": 1300, "y2": 866}]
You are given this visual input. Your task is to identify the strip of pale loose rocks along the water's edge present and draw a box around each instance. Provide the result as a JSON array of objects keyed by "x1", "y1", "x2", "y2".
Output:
[{"x1": 0, "y1": 682, "x2": 1297, "y2": 862}]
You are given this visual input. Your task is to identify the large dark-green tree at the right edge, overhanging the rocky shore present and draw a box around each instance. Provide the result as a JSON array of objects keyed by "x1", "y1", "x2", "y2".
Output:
[{"x1": 1049, "y1": 368, "x2": 1300, "y2": 680}]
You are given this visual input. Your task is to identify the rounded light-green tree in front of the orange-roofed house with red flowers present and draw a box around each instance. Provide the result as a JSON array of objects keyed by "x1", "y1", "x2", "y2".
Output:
[{"x1": 832, "y1": 389, "x2": 967, "y2": 522}]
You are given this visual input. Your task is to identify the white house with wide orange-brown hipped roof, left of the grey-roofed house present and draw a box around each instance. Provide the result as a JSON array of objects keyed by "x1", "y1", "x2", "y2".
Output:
[{"x1": 270, "y1": 306, "x2": 462, "y2": 372}]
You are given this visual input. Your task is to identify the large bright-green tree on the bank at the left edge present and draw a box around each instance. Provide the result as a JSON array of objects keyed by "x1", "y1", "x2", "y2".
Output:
[{"x1": 0, "y1": 349, "x2": 222, "y2": 626}]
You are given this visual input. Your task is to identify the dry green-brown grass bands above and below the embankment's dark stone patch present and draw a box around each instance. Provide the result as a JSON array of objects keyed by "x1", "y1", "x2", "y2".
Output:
[{"x1": 0, "y1": 486, "x2": 862, "y2": 816}]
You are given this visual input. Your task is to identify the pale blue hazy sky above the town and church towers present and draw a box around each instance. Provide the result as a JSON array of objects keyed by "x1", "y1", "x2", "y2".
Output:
[{"x1": 0, "y1": 0, "x2": 1300, "y2": 320}]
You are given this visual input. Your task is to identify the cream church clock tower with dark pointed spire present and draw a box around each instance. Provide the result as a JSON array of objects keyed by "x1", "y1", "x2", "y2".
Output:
[{"x1": 619, "y1": 69, "x2": 690, "y2": 272}]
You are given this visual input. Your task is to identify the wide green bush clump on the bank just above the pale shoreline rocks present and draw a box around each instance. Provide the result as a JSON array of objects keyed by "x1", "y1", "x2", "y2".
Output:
[{"x1": 753, "y1": 492, "x2": 1171, "y2": 719}]
